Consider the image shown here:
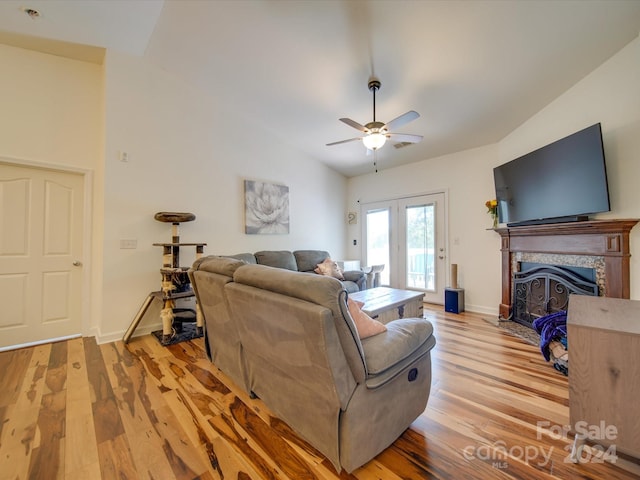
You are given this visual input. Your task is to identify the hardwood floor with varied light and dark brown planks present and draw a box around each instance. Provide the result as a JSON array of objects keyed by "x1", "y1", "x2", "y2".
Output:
[{"x1": 0, "y1": 305, "x2": 640, "y2": 480}]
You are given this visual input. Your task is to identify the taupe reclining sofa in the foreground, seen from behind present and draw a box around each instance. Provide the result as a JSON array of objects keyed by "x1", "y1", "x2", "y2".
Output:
[{"x1": 189, "y1": 256, "x2": 435, "y2": 472}]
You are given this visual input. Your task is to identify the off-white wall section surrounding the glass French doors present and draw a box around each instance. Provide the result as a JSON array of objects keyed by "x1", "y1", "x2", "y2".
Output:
[{"x1": 347, "y1": 145, "x2": 501, "y2": 314}]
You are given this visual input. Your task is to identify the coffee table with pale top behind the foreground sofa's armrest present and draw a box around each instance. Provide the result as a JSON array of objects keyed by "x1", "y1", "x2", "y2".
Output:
[{"x1": 349, "y1": 287, "x2": 424, "y2": 323}]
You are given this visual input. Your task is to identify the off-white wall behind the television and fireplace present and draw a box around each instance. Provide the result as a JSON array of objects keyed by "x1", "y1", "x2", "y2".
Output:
[{"x1": 498, "y1": 38, "x2": 640, "y2": 300}]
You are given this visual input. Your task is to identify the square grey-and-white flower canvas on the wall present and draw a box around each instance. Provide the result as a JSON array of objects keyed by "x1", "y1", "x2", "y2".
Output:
[{"x1": 244, "y1": 180, "x2": 289, "y2": 234}]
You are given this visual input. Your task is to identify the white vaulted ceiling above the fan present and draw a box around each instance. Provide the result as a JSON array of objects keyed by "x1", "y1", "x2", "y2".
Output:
[{"x1": 0, "y1": 0, "x2": 640, "y2": 176}]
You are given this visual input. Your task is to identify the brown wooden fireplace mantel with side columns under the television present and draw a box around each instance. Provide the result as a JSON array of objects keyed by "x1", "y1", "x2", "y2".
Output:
[{"x1": 496, "y1": 219, "x2": 638, "y2": 318}]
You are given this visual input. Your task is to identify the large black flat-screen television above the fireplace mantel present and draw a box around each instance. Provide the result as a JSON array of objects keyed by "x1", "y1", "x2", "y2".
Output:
[{"x1": 493, "y1": 123, "x2": 610, "y2": 227}]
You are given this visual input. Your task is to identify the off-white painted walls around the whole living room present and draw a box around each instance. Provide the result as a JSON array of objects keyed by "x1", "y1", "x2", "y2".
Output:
[{"x1": 0, "y1": 31, "x2": 640, "y2": 340}]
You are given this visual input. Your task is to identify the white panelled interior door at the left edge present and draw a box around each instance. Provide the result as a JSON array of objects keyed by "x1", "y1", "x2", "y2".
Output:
[{"x1": 0, "y1": 163, "x2": 84, "y2": 348}]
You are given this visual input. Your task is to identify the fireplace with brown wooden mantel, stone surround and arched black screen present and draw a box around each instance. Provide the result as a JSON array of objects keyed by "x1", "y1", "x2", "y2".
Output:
[{"x1": 496, "y1": 219, "x2": 638, "y2": 326}]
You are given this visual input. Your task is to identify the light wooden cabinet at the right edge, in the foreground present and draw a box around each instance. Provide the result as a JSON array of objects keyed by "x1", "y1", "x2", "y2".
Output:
[{"x1": 567, "y1": 295, "x2": 640, "y2": 458}]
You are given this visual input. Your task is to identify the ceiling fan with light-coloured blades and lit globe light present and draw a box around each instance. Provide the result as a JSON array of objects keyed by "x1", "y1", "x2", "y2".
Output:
[{"x1": 327, "y1": 78, "x2": 422, "y2": 153}]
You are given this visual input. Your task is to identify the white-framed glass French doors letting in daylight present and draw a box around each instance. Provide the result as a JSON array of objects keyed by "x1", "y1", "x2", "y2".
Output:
[{"x1": 361, "y1": 193, "x2": 446, "y2": 303}]
